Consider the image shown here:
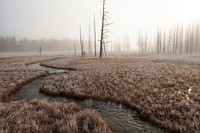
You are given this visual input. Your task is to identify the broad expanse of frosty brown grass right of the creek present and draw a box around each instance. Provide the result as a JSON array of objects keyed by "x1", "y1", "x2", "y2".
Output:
[{"x1": 40, "y1": 55, "x2": 200, "y2": 132}]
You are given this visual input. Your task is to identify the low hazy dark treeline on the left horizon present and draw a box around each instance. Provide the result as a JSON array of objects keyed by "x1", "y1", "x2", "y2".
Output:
[{"x1": 0, "y1": 36, "x2": 79, "y2": 52}]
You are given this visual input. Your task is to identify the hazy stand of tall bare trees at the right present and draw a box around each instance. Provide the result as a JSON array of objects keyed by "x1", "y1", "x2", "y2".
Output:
[{"x1": 138, "y1": 23, "x2": 200, "y2": 54}]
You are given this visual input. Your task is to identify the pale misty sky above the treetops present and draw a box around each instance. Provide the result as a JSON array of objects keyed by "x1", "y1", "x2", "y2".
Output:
[{"x1": 0, "y1": 0, "x2": 200, "y2": 48}]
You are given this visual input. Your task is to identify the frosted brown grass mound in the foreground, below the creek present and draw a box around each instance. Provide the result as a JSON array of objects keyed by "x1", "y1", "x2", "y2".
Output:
[{"x1": 0, "y1": 100, "x2": 112, "y2": 133}]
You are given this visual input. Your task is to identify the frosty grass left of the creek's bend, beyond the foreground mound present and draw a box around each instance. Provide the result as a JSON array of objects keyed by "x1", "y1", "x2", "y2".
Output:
[{"x1": 0, "y1": 56, "x2": 69, "y2": 101}]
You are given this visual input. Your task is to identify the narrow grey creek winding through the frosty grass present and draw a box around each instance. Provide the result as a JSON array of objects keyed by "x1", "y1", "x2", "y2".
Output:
[{"x1": 11, "y1": 63, "x2": 166, "y2": 133}]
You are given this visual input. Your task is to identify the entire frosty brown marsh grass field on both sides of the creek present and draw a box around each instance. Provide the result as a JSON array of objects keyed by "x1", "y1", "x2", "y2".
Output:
[{"x1": 0, "y1": 54, "x2": 200, "y2": 133}]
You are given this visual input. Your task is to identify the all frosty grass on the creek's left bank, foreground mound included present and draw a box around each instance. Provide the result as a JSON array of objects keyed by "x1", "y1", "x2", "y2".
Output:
[{"x1": 0, "y1": 57, "x2": 112, "y2": 133}]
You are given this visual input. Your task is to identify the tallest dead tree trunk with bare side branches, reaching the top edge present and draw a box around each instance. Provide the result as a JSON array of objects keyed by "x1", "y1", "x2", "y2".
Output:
[{"x1": 99, "y1": 0, "x2": 111, "y2": 58}]
